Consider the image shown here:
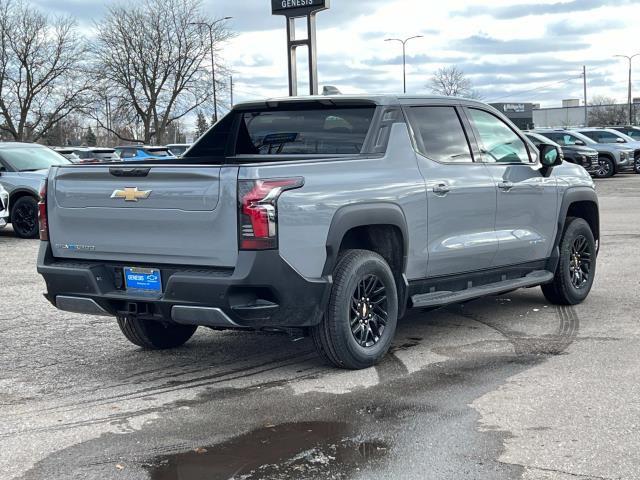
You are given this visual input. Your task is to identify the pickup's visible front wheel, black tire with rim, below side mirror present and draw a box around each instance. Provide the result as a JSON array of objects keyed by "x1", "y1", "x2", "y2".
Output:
[{"x1": 542, "y1": 217, "x2": 597, "y2": 305}]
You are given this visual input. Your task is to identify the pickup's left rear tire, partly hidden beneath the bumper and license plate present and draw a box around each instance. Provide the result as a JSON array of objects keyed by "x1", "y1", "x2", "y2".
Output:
[{"x1": 118, "y1": 315, "x2": 198, "y2": 350}]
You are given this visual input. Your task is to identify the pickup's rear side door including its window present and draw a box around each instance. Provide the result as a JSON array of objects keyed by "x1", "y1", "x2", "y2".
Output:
[{"x1": 407, "y1": 105, "x2": 498, "y2": 277}]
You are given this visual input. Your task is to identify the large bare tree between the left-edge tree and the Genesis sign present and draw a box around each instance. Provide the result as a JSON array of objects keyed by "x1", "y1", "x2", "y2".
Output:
[{"x1": 94, "y1": 0, "x2": 232, "y2": 143}]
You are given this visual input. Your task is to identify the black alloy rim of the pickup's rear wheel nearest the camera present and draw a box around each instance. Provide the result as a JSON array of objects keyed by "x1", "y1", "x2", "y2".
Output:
[{"x1": 351, "y1": 275, "x2": 388, "y2": 348}]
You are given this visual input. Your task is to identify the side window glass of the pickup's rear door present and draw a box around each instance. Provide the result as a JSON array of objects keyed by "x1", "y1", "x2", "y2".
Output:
[{"x1": 410, "y1": 107, "x2": 473, "y2": 163}]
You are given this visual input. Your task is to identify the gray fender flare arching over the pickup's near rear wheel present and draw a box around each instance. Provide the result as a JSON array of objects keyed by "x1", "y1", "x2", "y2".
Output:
[{"x1": 322, "y1": 202, "x2": 409, "y2": 276}]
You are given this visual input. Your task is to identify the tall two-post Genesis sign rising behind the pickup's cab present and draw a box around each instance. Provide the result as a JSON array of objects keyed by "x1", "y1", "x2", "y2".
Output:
[{"x1": 271, "y1": 0, "x2": 330, "y2": 97}]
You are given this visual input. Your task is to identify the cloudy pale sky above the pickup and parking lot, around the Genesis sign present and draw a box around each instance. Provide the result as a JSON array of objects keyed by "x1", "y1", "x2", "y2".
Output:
[{"x1": 36, "y1": 0, "x2": 640, "y2": 106}]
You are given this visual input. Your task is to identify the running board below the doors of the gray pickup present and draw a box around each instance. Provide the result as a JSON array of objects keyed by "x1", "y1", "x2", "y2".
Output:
[{"x1": 411, "y1": 270, "x2": 553, "y2": 308}]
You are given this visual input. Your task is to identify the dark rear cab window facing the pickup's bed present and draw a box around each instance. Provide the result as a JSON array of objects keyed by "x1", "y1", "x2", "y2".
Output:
[{"x1": 235, "y1": 106, "x2": 375, "y2": 155}]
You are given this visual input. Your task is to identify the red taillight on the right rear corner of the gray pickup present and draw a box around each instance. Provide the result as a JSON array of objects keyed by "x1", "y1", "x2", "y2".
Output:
[{"x1": 238, "y1": 178, "x2": 304, "y2": 250}]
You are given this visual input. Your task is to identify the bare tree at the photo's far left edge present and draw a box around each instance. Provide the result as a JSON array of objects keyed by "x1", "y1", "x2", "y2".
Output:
[{"x1": 0, "y1": 0, "x2": 89, "y2": 141}]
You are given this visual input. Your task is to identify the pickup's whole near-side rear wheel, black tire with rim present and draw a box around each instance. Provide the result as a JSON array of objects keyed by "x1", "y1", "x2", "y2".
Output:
[{"x1": 311, "y1": 250, "x2": 398, "y2": 370}]
